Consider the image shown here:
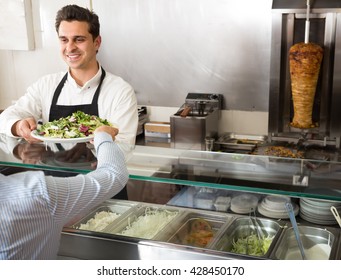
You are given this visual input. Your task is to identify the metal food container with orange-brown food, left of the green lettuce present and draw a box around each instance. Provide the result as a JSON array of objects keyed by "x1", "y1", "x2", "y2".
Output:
[{"x1": 160, "y1": 211, "x2": 233, "y2": 248}]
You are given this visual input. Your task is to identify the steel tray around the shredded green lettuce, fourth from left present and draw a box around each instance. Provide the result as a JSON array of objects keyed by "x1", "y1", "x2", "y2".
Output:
[{"x1": 212, "y1": 217, "x2": 284, "y2": 259}]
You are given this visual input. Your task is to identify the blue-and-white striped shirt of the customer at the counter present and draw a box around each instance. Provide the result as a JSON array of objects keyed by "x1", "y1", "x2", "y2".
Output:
[{"x1": 0, "y1": 132, "x2": 128, "y2": 259}]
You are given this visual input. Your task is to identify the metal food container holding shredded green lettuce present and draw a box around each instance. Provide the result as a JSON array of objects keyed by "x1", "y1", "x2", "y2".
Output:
[{"x1": 212, "y1": 217, "x2": 283, "y2": 258}]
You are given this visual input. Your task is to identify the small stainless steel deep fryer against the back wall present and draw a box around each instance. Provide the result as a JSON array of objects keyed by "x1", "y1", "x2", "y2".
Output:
[{"x1": 170, "y1": 93, "x2": 222, "y2": 150}]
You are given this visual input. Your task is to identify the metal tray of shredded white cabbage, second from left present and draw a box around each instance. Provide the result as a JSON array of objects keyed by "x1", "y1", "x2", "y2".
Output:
[{"x1": 105, "y1": 203, "x2": 183, "y2": 240}]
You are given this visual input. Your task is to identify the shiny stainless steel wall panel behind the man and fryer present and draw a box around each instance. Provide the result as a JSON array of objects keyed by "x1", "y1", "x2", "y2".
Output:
[{"x1": 92, "y1": 0, "x2": 272, "y2": 112}]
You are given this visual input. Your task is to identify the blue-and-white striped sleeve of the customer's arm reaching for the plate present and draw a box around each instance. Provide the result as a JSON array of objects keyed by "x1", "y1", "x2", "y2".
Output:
[{"x1": 46, "y1": 132, "x2": 129, "y2": 224}]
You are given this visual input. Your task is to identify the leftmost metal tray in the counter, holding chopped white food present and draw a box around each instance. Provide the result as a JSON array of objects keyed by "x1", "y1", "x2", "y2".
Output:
[{"x1": 70, "y1": 200, "x2": 138, "y2": 232}]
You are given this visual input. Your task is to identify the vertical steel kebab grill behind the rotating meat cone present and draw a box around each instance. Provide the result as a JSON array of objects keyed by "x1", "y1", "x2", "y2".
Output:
[{"x1": 268, "y1": 0, "x2": 341, "y2": 148}]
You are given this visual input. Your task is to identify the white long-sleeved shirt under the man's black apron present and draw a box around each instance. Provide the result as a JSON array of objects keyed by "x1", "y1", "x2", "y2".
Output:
[{"x1": 0, "y1": 67, "x2": 138, "y2": 149}]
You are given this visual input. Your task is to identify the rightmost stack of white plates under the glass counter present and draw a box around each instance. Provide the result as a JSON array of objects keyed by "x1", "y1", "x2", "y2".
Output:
[{"x1": 300, "y1": 198, "x2": 341, "y2": 225}]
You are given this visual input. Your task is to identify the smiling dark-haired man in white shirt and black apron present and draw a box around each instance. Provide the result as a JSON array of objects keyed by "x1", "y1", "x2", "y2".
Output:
[{"x1": 0, "y1": 5, "x2": 138, "y2": 150}]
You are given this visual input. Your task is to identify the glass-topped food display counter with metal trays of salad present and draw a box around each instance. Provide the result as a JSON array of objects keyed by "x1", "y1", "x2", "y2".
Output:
[{"x1": 0, "y1": 133, "x2": 341, "y2": 259}]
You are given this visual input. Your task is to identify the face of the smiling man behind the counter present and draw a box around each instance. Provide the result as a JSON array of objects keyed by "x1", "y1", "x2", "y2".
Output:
[{"x1": 58, "y1": 21, "x2": 101, "y2": 70}]
